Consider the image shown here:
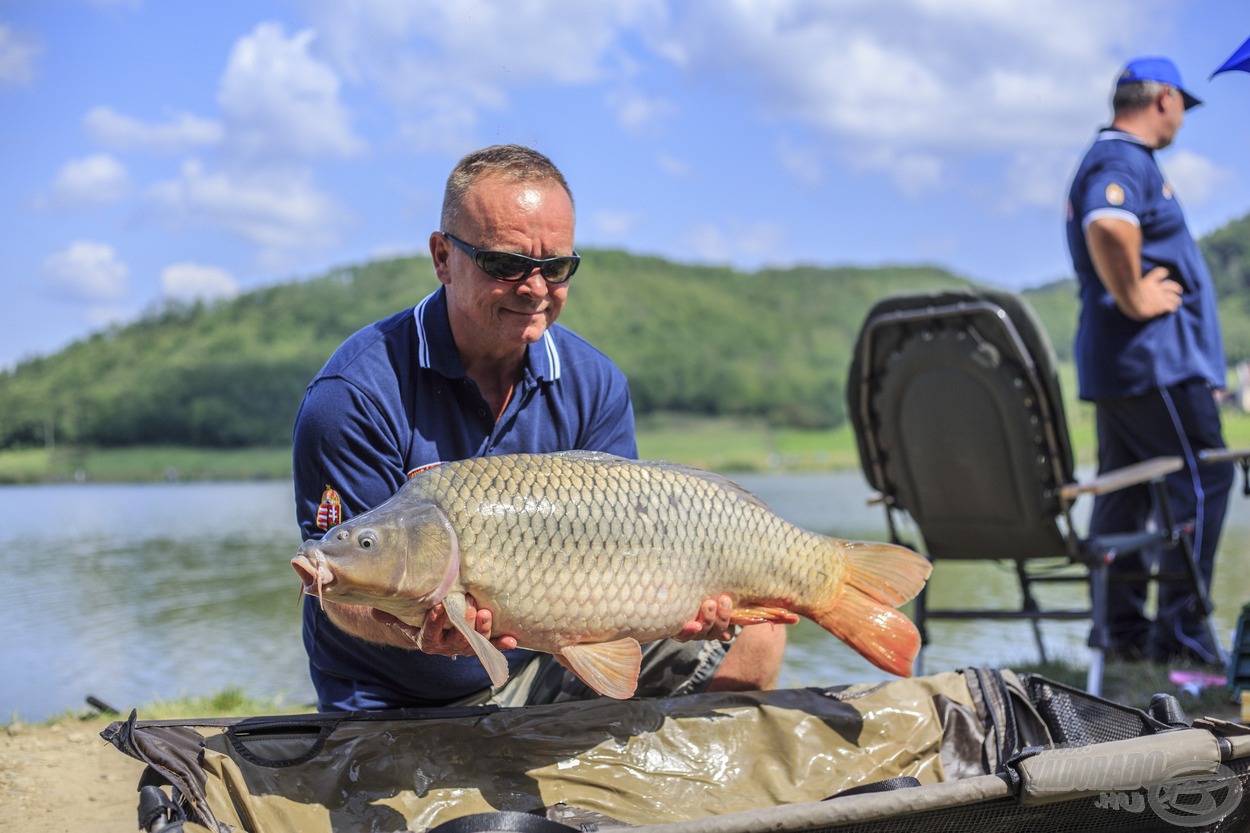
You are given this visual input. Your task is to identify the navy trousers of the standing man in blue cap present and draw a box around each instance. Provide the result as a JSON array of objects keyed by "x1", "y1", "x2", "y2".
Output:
[{"x1": 1090, "y1": 380, "x2": 1235, "y2": 663}]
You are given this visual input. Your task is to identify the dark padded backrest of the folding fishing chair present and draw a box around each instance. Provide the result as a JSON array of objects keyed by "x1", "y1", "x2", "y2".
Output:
[{"x1": 846, "y1": 289, "x2": 1073, "y2": 559}]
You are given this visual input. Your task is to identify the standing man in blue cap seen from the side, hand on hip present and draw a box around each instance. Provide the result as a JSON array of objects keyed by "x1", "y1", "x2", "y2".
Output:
[{"x1": 1068, "y1": 58, "x2": 1233, "y2": 663}]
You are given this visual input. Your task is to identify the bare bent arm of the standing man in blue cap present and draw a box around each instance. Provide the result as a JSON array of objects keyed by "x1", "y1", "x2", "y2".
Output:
[{"x1": 1085, "y1": 216, "x2": 1181, "y2": 321}]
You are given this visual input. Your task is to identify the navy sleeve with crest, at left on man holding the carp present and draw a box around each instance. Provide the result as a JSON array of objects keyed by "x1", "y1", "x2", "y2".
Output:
[{"x1": 291, "y1": 378, "x2": 405, "y2": 540}]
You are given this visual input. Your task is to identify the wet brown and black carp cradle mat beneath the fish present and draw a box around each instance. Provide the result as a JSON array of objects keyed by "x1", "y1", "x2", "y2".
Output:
[{"x1": 104, "y1": 669, "x2": 1250, "y2": 833}]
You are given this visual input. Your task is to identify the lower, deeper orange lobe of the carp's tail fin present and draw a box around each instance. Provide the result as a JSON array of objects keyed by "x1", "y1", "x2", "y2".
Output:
[{"x1": 813, "y1": 587, "x2": 920, "y2": 677}]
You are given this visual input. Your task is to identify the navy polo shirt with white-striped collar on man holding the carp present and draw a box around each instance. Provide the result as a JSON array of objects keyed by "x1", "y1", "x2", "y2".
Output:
[{"x1": 294, "y1": 288, "x2": 638, "y2": 710}]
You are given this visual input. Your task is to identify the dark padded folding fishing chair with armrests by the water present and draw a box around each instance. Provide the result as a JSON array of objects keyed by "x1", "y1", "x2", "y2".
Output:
[{"x1": 846, "y1": 289, "x2": 1219, "y2": 694}]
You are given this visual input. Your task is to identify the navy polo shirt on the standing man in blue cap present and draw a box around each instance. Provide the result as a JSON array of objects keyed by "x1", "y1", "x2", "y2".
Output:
[{"x1": 1066, "y1": 128, "x2": 1225, "y2": 400}]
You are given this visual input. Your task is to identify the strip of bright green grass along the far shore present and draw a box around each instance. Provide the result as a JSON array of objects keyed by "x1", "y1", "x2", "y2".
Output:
[{"x1": 0, "y1": 404, "x2": 1250, "y2": 483}]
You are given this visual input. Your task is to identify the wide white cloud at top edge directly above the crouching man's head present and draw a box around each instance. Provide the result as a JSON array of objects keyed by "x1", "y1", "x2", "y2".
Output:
[{"x1": 301, "y1": 0, "x2": 666, "y2": 153}]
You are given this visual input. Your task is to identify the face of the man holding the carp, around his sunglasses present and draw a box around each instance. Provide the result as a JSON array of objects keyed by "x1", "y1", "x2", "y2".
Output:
[{"x1": 430, "y1": 176, "x2": 574, "y2": 359}]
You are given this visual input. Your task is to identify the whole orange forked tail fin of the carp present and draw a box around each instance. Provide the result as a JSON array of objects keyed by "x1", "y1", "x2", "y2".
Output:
[{"x1": 811, "y1": 542, "x2": 933, "y2": 677}]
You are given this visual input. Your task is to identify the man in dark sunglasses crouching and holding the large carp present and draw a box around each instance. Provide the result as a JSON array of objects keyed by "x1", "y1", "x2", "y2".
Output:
[{"x1": 294, "y1": 145, "x2": 785, "y2": 710}]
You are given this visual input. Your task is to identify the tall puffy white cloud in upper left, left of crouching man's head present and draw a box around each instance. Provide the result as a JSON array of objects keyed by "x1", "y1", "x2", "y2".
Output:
[{"x1": 218, "y1": 23, "x2": 365, "y2": 163}]
